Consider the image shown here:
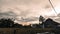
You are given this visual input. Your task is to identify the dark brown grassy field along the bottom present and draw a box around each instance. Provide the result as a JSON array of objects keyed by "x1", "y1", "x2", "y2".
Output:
[{"x1": 0, "y1": 28, "x2": 60, "y2": 34}]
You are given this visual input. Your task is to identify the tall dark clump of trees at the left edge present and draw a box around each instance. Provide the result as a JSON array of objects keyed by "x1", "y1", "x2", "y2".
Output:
[{"x1": 0, "y1": 18, "x2": 14, "y2": 27}]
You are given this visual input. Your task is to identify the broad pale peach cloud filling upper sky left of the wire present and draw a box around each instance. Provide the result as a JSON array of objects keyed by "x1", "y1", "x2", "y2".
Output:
[{"x1": 0, "y1": 0, "x2": 51, "y2": 16}]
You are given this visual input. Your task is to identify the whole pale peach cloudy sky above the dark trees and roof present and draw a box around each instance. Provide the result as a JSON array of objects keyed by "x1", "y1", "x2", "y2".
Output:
[{"x1": 0, "y1": 0, "x2": 60, "y2": 23}]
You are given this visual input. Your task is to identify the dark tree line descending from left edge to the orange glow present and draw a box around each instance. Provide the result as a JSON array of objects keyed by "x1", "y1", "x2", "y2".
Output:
[{"x1": 0, "y1": 18, "x2": 31, "y2": 28}]
